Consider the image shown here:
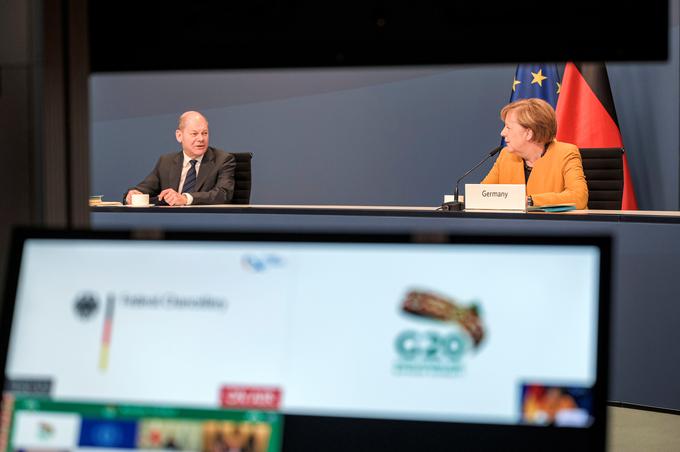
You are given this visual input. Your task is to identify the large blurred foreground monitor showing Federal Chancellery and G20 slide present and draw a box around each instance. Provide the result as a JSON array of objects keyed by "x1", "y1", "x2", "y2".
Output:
[{"x1": 2, "y1": 234, "x2": 606, "y2": 452}]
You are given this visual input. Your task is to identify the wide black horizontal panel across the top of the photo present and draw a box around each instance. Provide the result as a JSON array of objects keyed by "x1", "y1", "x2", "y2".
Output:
[{"x1": 87, "y1": 0, "x2": 669, "y2": 72}]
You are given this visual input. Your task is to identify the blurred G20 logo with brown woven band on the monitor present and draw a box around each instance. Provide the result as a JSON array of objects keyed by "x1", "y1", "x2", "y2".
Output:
[{"x1": 393, "y1": 290, "x2": 485, "y2": 376}]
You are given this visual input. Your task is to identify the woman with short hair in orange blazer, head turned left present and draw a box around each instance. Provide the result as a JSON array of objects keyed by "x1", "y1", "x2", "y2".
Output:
[{"x1": 482, "y1": 99, "x2": 588, "y2": 209}]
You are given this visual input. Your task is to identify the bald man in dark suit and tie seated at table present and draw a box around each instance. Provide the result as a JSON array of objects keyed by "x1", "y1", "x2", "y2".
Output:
[{"x1": 125, "y1": 111, "x2": 236, "y2": 206}]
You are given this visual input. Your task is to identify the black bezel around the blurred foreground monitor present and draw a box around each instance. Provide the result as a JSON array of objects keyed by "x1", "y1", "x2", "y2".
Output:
[{"x1": 0, "y1": 228, "x2": 612, "y2": 452}]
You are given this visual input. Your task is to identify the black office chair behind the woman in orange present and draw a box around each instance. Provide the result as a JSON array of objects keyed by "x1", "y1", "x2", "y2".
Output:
[{"x1": 581, "y1": 148, "x2": 623, "y2": 210}]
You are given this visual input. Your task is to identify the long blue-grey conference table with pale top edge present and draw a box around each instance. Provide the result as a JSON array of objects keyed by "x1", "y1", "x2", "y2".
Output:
[{"x1": 91, "y1": 205, "x2": 680, "y2": 410}]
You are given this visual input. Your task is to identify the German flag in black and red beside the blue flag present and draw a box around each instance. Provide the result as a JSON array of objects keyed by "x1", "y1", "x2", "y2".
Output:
[{"x1": 557, "y1": 62, "x2": 637, "y2": 210}]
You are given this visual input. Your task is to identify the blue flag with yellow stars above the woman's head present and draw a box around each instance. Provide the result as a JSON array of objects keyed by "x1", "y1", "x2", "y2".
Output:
[{"x1": 510, "y1": 64, "x2": 561, "y2": 108}]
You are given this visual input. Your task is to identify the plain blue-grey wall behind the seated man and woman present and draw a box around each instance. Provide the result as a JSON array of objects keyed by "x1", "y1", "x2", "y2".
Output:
[{"x1": 90, "y1": 3, "x2": 680, "y2": 210}]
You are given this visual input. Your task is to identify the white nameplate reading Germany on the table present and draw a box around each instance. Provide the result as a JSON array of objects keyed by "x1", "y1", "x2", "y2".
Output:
[{"x1": 465, "y1": 184, "x2": 527, "y2": 212}]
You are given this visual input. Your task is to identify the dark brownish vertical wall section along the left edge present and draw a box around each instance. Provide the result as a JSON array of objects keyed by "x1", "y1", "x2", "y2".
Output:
[{"x1": 0, "y1": 0, "x2": 90, "y2": 322}]
